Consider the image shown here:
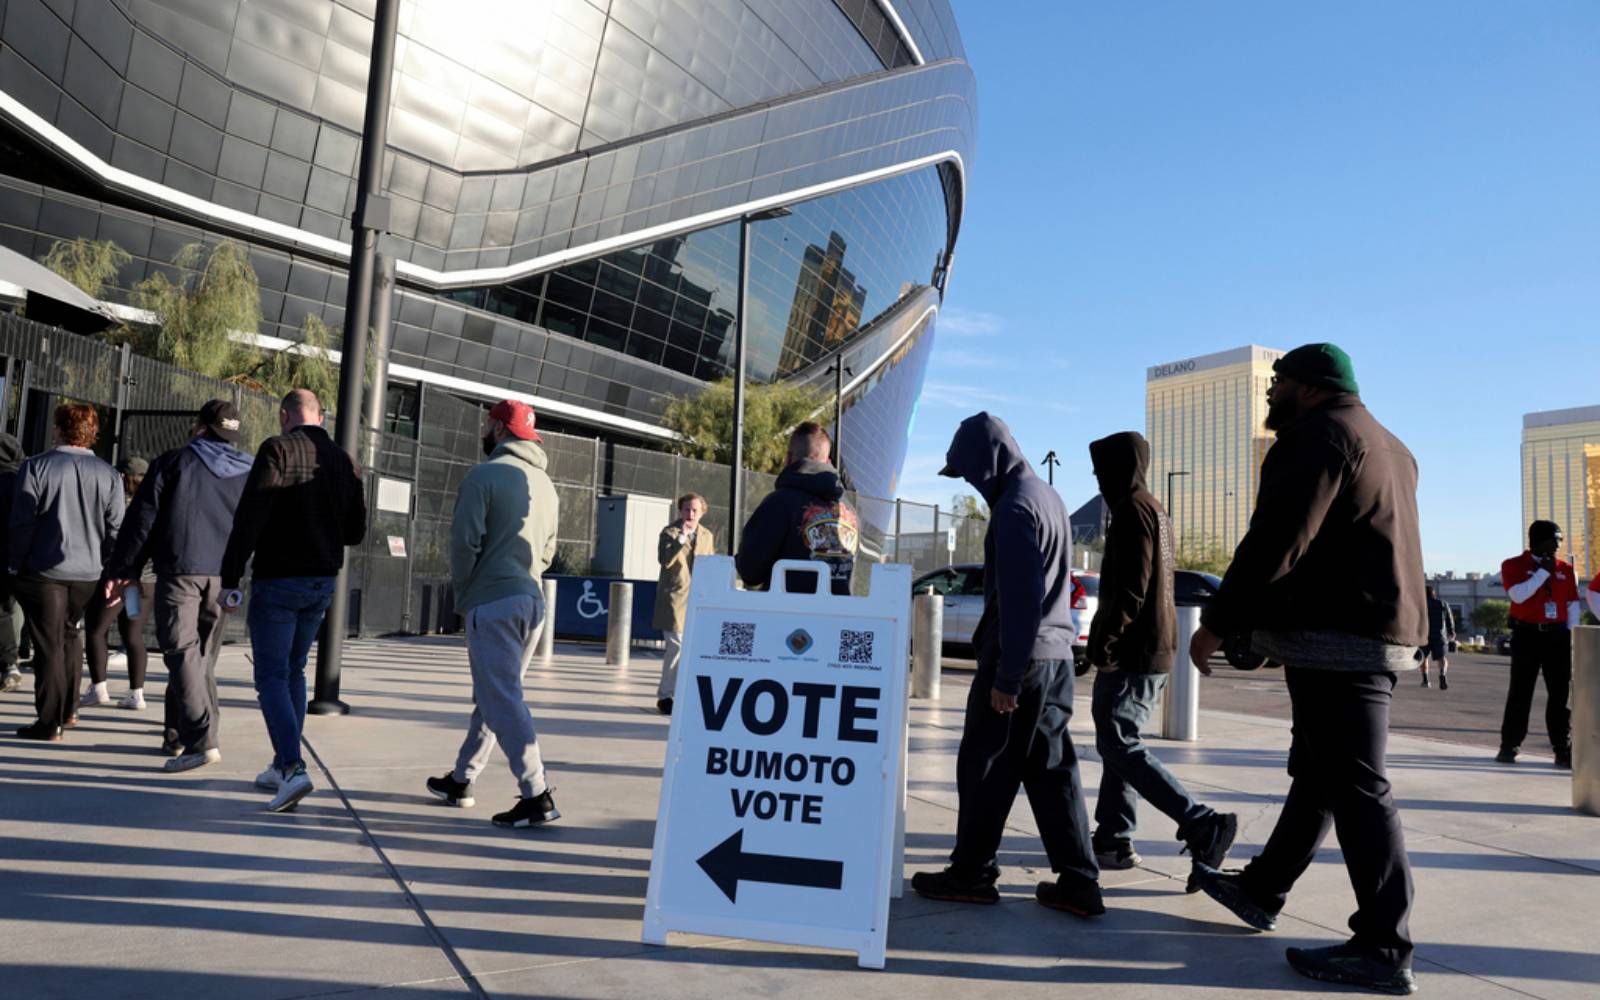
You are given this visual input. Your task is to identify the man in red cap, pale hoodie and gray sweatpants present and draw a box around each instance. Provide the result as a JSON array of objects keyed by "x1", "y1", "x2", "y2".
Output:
[{"x1": 427, "y1": 400, "x2": 562, "y2": 827}]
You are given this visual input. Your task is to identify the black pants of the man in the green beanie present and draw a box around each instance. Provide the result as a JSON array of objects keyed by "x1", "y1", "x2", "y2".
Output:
[{"x1": 1243, "y1": 667, "x2": 1414, "y2": 968}]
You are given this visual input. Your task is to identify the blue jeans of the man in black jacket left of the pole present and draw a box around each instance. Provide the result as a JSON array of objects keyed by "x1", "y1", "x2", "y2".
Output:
[{"x1": 248, "y1": 576, "x2": 334, "y2": 771}]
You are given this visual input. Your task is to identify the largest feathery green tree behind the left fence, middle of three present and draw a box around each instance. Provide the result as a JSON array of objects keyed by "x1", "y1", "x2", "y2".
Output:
[{"x1": 126, "y1": 240, "x2": 261, "y2": 379}]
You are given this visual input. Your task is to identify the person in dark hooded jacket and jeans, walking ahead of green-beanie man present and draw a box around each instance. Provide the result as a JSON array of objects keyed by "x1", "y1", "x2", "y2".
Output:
[{"x1": 1088, "y1": 430, "x2": 1238, "y2": 893}]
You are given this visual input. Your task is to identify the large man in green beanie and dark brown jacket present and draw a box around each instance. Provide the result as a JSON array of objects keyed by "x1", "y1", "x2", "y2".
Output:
[{"x1": 1189, "y1": 344, "x2": 1427, "y2": 994}]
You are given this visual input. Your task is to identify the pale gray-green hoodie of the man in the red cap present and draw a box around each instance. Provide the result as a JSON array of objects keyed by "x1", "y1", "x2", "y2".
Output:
[{"x1": 450, "y1": 438, "x2": 560, "y2": 614}]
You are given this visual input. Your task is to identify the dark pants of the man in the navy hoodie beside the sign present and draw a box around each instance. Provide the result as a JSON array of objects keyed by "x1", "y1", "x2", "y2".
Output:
[{"x1": 950, "y1": 659, "x2": 1099, "y2": 882}]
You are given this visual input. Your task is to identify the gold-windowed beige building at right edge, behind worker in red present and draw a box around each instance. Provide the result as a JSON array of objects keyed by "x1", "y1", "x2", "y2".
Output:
[{"x1": 1522, "y1": 406, "x2": 1600, "y2": 578}]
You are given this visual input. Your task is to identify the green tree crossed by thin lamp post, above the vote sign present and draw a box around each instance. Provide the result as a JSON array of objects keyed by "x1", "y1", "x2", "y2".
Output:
[{"x1": 661, "y1": 379, "x2": 829, "y2": 474}]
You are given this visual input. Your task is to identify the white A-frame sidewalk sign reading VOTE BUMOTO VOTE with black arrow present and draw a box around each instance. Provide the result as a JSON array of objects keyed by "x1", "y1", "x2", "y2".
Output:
[{"x1": 643, "y1": 557, "x2": 910, "y2": 968}]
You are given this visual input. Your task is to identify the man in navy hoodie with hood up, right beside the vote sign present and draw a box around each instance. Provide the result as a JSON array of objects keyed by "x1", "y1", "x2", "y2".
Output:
[{"x1": 912, "y1": 413, "x2": 1106, "y2": 917}]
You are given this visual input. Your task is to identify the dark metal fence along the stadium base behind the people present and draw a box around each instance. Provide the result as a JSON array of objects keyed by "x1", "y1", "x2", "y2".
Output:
[{"x1": 0, "y1": 314, "x2": 1036, "y2": 634}]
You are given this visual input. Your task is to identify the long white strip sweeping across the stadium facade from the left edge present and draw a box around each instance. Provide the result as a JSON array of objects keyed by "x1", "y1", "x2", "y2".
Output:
[{"x1": 0, "y1": 90, "x2": 966, "y2": 290}]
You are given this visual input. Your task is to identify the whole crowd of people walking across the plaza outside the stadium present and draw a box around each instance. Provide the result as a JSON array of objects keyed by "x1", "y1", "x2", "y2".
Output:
[{"x1": 0, "y1": 344, "x2": 1600, "y2": 994}]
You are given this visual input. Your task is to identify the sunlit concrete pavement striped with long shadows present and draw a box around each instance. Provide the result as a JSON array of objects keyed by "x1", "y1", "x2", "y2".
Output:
[{"x1": 0, "y1": 638, "x2": 1600, "y2": 1000}]
